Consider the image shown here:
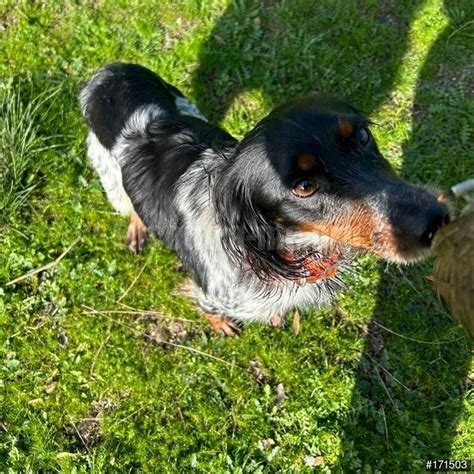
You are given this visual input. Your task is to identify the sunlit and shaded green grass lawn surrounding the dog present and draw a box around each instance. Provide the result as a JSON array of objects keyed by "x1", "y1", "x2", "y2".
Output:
[{"x1": 0, "y1": 0, "x2": 474, "y2": 472}]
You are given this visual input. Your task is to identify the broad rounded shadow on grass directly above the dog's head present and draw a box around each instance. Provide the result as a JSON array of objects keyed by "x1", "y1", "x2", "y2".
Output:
[{"x1": 192, "y1": 0, "x2": 423, "y2": 122}]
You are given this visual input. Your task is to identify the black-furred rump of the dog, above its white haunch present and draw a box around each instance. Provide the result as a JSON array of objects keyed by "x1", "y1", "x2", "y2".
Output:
[{"x1": 79, "y1": 62, "x2": 206, "y2": 150}]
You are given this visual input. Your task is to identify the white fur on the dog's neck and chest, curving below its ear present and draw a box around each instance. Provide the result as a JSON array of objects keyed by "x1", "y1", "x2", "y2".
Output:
[{"x1": 176, "y1": 151, "x2": 332, "y2": 323}]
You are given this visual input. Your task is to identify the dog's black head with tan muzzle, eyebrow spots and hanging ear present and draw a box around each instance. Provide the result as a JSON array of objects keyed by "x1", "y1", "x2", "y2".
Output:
[{"x1": 215, "y1": 97, "x2": 449, "y2": 278}]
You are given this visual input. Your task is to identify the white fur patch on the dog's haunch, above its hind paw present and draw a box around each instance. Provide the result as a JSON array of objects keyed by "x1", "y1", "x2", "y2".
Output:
[{"x1": 84, "y1": 132, "x2": 133, "y2": 215}]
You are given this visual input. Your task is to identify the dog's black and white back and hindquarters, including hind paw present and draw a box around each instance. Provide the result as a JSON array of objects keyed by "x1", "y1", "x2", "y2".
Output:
[{"x1": 80, "y1": 63, "x2": 239, "y2": 252}]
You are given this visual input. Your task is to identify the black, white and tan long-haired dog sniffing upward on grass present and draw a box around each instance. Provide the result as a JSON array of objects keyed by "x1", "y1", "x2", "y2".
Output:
[{"x1": 80, "y1": 63, "x2": 449, "y2": 336}]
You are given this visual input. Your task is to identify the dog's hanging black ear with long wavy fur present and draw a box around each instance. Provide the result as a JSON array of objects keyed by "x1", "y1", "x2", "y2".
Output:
[{"x1": 214, "y1": 172, "x2": 294, "y2": 279}]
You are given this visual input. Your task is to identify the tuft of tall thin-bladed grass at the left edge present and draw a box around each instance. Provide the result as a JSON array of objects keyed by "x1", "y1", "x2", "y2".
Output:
[{"x1": 0, "y1": 78, "x2": 59, "y2": 226}]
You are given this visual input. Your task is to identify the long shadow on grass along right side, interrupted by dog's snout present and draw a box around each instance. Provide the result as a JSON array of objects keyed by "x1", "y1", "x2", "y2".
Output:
[{"x1": 341, "y1": 2, "x2": 474, "y2": 470}]
